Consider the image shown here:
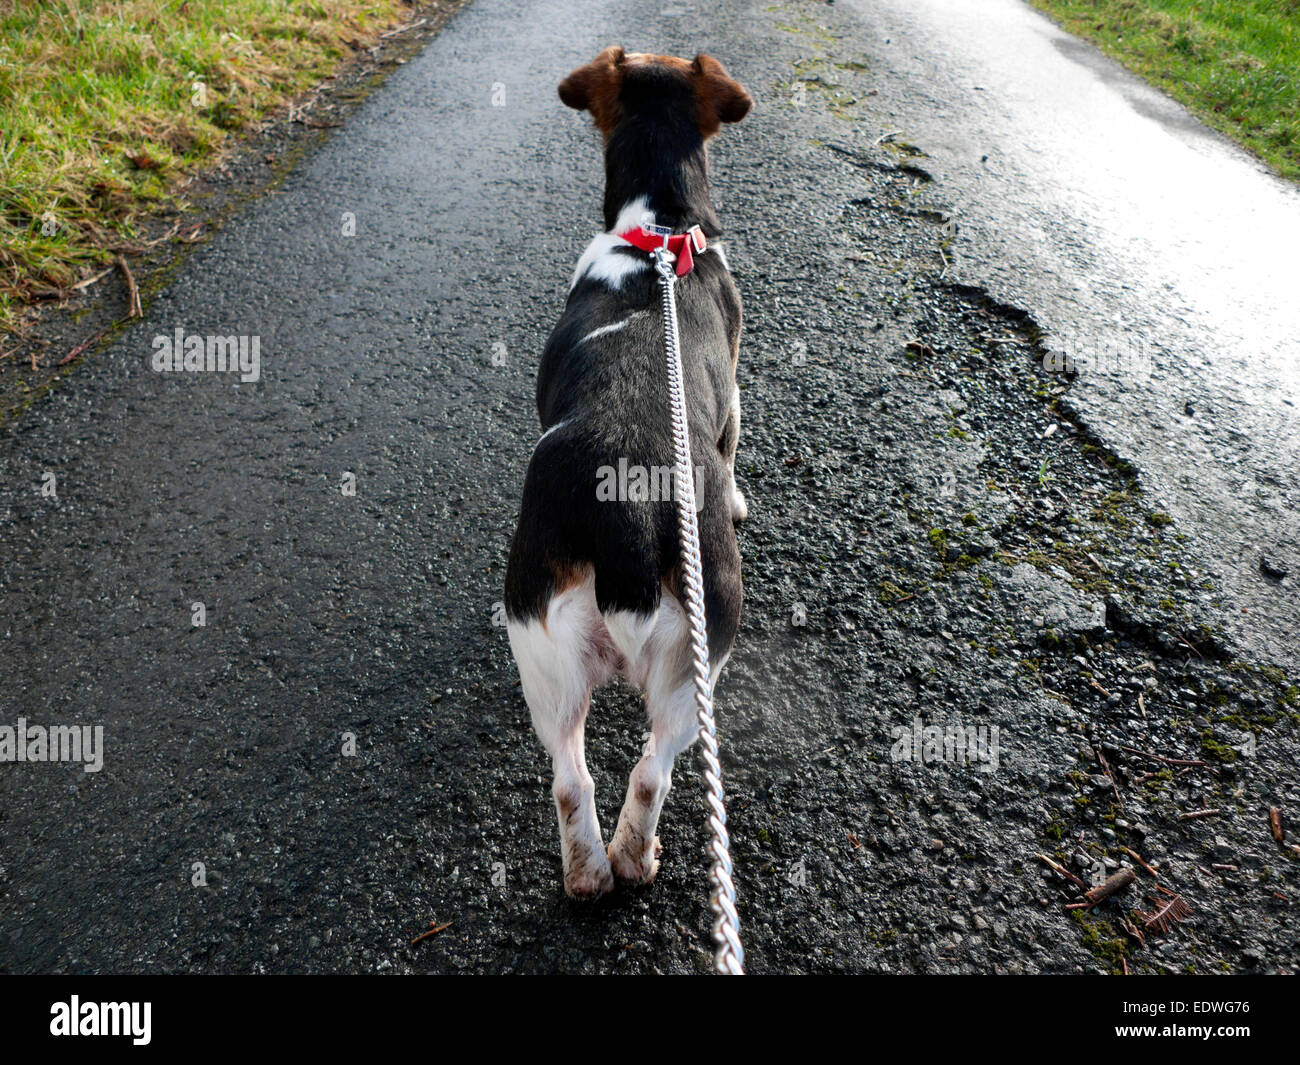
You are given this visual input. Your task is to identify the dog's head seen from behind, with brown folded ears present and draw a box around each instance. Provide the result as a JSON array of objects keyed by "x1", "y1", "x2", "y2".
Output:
[{"x1": 559, "y1": 46, "x2": 754, "y2": 140}]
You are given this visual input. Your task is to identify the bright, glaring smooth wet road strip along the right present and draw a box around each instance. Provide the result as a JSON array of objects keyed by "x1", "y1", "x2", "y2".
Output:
[{"x1": 850, "y1": 0, "x2": 1300, "y2": 668}]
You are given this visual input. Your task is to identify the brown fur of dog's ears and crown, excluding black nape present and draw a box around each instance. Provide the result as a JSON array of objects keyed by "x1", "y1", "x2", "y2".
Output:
[{"x1": 559, "y1": 44, "x2": 754, "y2": 140}]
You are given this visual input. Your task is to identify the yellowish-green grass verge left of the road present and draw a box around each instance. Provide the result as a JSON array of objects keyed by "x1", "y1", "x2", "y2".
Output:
[{"x1": 0, "y1": 0, "x2": 407, "y2": 330}]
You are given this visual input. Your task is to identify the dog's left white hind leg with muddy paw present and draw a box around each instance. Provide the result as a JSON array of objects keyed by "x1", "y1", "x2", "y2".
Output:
[{"x1": 507, "y1": 579, "x2": 614, "y2": 899}]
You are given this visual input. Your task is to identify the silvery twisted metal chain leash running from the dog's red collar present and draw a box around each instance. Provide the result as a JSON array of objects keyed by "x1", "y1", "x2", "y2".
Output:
[{"x1": 654, "y1": 248, "x2": 745, "y2": 977}]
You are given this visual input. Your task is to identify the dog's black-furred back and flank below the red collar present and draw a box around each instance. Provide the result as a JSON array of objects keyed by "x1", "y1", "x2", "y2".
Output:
[{"x1": 506, "y1": 217, "x2": 740, "y2": 655}]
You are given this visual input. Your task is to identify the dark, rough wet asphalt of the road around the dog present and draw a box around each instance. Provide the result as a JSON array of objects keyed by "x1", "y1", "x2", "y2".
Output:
[{"x1": 0, "y1": 0, "x2": 1300, "y2": 973}]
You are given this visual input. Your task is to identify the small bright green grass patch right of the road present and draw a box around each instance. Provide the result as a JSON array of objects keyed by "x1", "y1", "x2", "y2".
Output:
[{"x1": 1031, "y1": 0, "x2": 1300, "y2": 181}]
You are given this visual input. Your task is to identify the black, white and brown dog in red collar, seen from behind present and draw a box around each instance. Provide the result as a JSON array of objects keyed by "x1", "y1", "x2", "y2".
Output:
[{"x1": 506, "y1": 47, "x2": 753, "y2": 899}]
